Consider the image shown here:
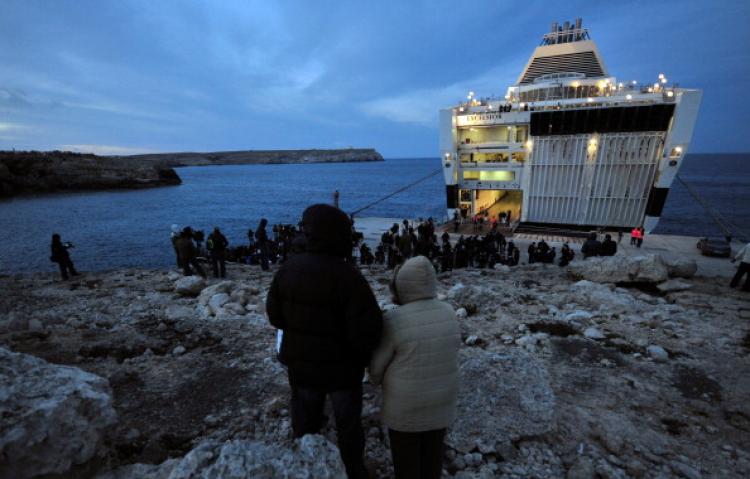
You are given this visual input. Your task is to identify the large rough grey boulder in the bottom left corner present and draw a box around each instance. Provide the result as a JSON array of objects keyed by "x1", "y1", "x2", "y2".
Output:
[{"x1": 0, "y1": 348, "x2": 117, "y2": 478}]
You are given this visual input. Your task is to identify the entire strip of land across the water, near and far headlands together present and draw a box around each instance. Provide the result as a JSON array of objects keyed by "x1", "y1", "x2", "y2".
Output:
[{"x1": 0, "y1": 148, "x2": 383, "y2": 197}]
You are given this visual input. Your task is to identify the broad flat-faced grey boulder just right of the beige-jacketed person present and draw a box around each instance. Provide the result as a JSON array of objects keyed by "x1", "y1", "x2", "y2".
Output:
[{"x1": 446, "y1": 348, "x2": 555, "y2": 453}]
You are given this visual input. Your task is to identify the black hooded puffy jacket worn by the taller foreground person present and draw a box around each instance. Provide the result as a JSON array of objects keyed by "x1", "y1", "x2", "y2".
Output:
[{"x1": 266, "y1": 205, "x2": 382, "y2": 391}]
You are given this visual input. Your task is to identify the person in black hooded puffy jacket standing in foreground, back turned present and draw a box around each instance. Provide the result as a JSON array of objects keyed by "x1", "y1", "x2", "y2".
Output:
[{"x1": 266, "y1": 204, "x2": 382, "y2": 477}]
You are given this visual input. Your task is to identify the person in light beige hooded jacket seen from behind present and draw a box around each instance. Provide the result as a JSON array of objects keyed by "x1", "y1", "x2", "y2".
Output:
[{"x1": 370, "y1": 256, "x2": 461, "y2": 478}]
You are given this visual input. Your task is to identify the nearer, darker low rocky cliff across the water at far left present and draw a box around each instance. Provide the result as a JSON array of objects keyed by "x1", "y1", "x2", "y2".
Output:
[{"x1": 0, "y1": 151, "x2": 182, "y2": 197}]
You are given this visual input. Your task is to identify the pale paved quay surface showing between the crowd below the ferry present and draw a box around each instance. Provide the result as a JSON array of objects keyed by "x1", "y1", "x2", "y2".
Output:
[{"x1": 354, "y1": 217, "x2": 743, "y2": 278}]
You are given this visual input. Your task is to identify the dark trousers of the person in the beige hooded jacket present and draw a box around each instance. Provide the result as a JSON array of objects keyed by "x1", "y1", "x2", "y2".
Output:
[{"x1": 388, "y1": 429, "x2": 445, "y2": 479}]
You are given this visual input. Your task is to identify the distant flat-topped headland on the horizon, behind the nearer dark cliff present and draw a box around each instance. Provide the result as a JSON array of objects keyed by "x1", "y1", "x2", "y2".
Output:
[{"x1": 126, "y1": 148, "x2": 383, "y2": 166}]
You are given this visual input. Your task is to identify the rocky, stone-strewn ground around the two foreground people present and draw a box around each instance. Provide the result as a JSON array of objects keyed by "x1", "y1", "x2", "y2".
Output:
[{"x1": 0, "y1": 257, "x2": 750, "y2": 479}]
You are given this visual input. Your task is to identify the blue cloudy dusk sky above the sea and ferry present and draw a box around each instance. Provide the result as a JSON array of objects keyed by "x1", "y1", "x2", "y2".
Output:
[{"x1": 0, "y1": 0, "x2": 750, "y2": 157}]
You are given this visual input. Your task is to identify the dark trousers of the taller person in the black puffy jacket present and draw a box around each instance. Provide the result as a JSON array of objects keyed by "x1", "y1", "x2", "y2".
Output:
[{"x1": 291, "y1": 385, "x2": 367, "y2": 478}]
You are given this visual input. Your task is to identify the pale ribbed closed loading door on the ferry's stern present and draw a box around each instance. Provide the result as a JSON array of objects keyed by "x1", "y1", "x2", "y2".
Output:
[{"x1": 525, "y1": 132, "x2": 664, "y2": 227}]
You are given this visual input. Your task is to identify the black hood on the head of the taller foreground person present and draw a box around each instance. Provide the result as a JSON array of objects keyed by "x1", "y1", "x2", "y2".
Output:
[{"x1": 302, "y1": 204, "x2": 352, "y2": 258}]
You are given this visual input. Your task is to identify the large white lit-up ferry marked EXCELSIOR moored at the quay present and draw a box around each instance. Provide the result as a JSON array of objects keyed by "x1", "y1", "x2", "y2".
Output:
[{"x1": 440, "y1": 19, "x2": 702, "y2": 232}]
